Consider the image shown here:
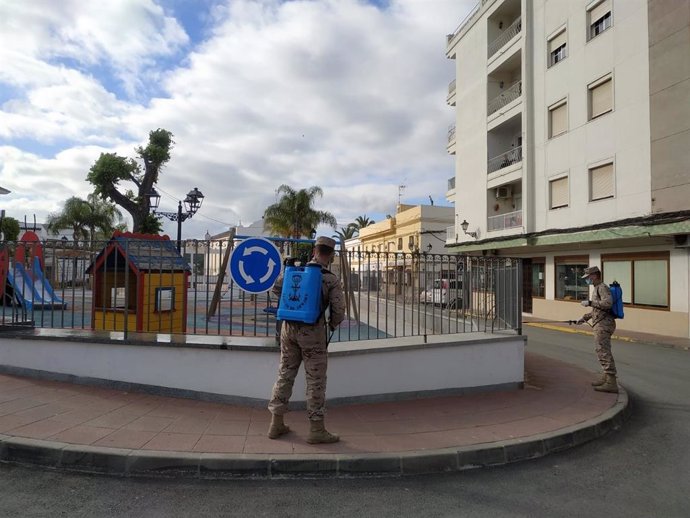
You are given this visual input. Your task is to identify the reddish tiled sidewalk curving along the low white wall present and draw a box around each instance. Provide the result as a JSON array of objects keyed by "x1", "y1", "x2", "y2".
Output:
[{"x1": 0, "y1": 353, "x2": 627, "y2": 475}]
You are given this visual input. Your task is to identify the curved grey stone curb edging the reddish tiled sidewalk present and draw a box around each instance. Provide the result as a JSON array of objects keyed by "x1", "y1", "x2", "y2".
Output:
[{"x1": 0, "y1": 387, "x2": 631, "y2": 479}]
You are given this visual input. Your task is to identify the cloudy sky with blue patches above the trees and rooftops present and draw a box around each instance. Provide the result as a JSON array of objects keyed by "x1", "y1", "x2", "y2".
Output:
[{"x1": 0, "y1": 0, "x2": 476, "y2": 237}]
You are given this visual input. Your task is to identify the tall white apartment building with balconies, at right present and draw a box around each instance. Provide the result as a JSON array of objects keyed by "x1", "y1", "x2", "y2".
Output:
[{"x1": 446, "y1": 0, "x2": 690, "y2": 337}]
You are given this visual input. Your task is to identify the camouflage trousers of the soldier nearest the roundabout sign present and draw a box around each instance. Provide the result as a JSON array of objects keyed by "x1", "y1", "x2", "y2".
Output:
[{"x1": 268, "y1": 322, "x2": 328, "y2": 421}]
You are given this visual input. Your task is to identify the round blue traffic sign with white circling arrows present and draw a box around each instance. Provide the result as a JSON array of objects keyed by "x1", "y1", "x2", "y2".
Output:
[{"x1": 229, "y1": 237, "x2": 283, "y2": 293}]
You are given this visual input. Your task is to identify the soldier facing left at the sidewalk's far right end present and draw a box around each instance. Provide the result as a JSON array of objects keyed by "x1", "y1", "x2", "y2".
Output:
[{"x1": 577, "y1": 266, "x2": 618, "y2": 393}]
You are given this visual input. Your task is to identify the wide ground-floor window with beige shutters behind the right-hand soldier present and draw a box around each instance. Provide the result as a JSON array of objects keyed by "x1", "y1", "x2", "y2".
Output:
[{"x1": 602, "y1": 252, "x2": 669, "y2": 309}]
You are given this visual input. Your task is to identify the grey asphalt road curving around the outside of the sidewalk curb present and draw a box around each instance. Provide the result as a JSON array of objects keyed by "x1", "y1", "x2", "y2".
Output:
[{"x1": 0, "y1": 327, "x2": 690, "y2": 518}]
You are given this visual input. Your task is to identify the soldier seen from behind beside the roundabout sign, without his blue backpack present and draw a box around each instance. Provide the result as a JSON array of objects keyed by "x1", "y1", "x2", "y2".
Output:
[{"x1": 268, "y1": 236, "x2": 345, "y2": 444}]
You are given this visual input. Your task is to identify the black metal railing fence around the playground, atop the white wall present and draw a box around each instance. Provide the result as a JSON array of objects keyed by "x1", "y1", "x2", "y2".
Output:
[{"x1": 0, "y1": 240, "x2": 521, "y2": 341}]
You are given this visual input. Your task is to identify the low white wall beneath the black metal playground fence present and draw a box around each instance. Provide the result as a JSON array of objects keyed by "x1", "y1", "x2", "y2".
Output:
[{"x1": 0, "y1": 333, "x2": 524, "y2": 403}]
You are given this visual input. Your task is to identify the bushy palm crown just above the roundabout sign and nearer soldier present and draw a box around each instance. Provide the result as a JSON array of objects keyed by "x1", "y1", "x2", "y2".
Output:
[{"x1": 264, "y1": 184, "x2": 338, "y2": 238}]
